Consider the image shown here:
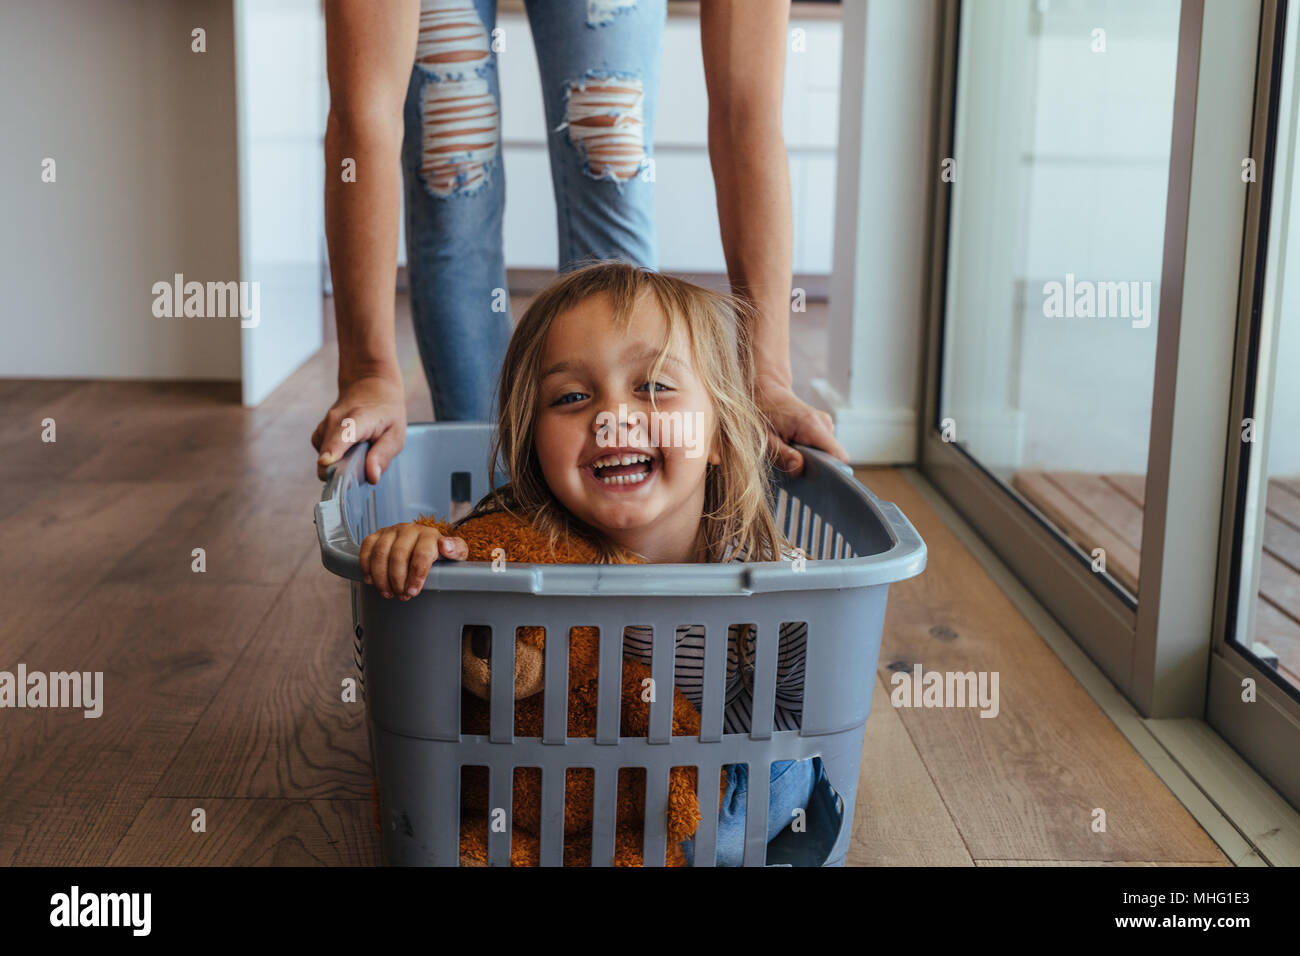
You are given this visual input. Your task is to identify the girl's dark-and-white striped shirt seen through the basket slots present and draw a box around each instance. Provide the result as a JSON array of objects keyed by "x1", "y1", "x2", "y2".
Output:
[{"x1": 623, "y1": 548, "x2": 809, "y2": 734}]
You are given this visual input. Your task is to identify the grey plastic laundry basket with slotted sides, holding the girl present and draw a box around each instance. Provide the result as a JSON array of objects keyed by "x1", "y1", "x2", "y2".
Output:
[{"x1": 316, "y1": 423, "x2": 926, "y2": 866}]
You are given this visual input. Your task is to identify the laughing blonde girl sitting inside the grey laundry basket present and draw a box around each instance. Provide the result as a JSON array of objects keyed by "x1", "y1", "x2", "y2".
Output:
[{"x1": 360, "y1": 263, "x2": 824, "y2": 866}]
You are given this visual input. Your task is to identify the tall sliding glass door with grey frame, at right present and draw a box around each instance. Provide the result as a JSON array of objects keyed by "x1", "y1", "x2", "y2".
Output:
[{"x1": 920, "y1": 0, "x2": 1300, "y2": 805}]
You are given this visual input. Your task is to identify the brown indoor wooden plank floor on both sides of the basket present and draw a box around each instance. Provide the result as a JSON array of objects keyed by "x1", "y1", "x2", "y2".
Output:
[{"x1": 0, "y1": 297, "x2": 1226, "y2": 866}]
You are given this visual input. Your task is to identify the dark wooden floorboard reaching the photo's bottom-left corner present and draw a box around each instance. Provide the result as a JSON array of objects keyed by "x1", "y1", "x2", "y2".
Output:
[{"x1": 0, "y1": 581, "x2": 280, "y2": 865}]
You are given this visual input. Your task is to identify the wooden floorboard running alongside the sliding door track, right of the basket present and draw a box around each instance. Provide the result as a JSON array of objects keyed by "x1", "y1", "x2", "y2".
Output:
[{"x1": 858, "y1": 470, "x2": 1226, "y2": 862}]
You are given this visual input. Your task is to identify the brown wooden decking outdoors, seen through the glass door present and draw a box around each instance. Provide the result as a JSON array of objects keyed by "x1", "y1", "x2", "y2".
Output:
[{"x1": 1011, "y1": 471, "x2": 1300, "y2": 687}]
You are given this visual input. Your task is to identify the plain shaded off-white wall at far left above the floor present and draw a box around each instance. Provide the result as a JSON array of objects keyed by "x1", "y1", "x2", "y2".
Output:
[{"x1": 0, "y1": 0, "x2": 239, "y2": 378}]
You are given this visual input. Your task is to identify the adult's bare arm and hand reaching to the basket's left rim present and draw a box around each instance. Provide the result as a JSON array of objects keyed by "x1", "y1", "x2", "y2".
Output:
[{"x1": 312, "y1": 0, "x2": 420, "y2": 483}]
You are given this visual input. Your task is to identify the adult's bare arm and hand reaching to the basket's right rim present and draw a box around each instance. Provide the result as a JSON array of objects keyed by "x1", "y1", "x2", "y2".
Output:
[{"x1": 699, "y1": 0, "x2": 848, "y2": 471}]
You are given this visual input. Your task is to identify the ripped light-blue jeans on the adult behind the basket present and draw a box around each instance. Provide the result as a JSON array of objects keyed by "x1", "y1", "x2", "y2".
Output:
[{"x1": 402, "y1": 0, "x2": 667, "y2": 421}]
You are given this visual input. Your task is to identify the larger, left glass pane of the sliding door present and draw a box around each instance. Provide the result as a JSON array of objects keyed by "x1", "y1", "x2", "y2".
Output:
[{"x1": 936, "y1": 0, "x2": 1179, "y2": 594}]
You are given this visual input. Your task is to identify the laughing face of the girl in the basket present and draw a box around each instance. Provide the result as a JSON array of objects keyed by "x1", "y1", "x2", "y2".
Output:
[{"x1": 536, "y1": 294, "x2": 722, "y2": 563}]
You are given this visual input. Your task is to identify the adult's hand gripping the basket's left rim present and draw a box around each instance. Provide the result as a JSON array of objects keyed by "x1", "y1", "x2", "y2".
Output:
[{"x1": 312, "y1": 373, "x2": 406, "y2": 485}]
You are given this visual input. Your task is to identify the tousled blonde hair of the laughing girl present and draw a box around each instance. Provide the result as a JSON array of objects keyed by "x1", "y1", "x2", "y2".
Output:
[{"x1": 460, "y1": 261, "x2": 788, "y2": 563}]
